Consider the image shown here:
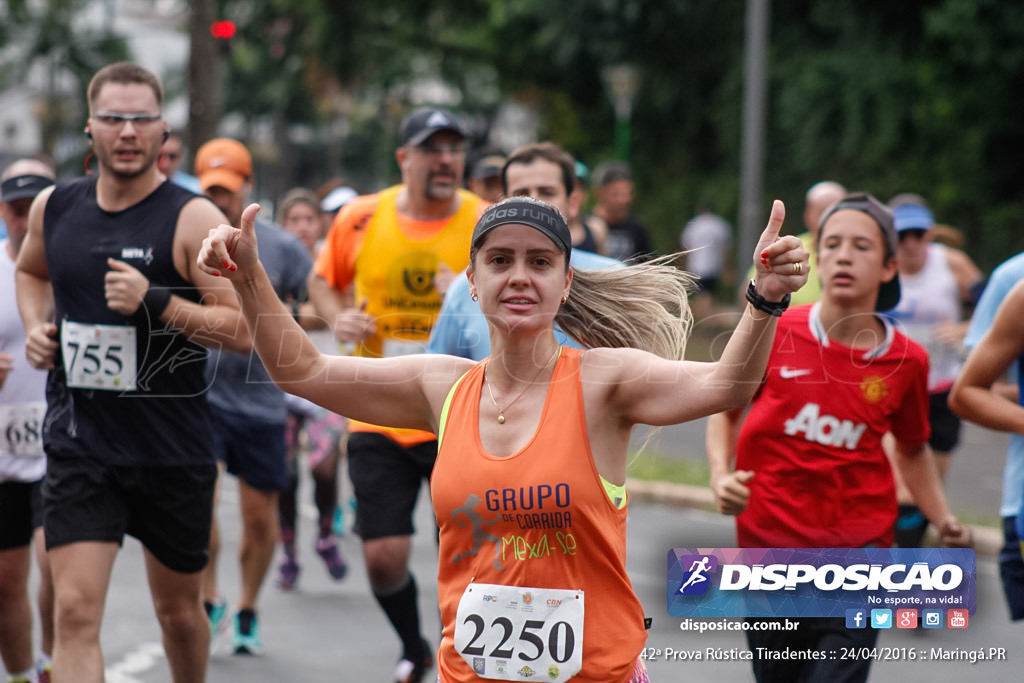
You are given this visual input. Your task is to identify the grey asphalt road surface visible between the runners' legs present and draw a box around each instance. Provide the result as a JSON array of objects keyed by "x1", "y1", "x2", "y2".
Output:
[{"x1": 22, "y1": 473, "x2": 1024, "y2": 683}]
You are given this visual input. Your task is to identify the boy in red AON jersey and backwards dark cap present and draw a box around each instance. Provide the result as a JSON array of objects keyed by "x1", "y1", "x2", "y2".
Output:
[{"x1": 708, "y1": 194, "x2": 971, "y2": 683}]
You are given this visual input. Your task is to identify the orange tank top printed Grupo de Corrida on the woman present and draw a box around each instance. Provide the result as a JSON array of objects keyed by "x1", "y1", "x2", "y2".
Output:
[{"x1": 430, "y1": 347, "x2": 647, "y2": 683}]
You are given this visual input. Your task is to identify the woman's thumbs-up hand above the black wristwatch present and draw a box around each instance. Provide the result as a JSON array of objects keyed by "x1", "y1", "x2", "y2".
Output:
[{"x1": 754, "y1": 200, "x2": 810, "y2": 301}]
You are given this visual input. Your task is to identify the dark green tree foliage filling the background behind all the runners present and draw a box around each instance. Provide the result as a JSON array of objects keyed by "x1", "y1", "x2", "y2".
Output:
[{"x1": 8, "y1": 0, "x2": 1024, "y2": 269}]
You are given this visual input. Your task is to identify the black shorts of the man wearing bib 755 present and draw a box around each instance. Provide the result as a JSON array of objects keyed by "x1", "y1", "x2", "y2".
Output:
[{"x1": 43, "y1": 451, "x2": 217, "y2": 573}]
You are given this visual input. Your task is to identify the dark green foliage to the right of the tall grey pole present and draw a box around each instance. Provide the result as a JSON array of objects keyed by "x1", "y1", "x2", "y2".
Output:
[{"x1": 768, "y1": 0, "x2": 1024, "y2": 269}]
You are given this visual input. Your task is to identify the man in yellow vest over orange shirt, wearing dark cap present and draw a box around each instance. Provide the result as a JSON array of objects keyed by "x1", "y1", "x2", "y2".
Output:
[{"x1": 309, "y1": 110, "x2": 486, "y2": 683}]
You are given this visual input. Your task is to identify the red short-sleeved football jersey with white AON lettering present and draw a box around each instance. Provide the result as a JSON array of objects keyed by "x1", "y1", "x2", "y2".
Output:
[{"x1": 736, "y1": 304, "x2": 929, "y2": 548}]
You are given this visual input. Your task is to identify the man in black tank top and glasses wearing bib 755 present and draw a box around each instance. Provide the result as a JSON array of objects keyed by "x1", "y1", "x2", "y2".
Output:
[{"x1": 16, "y1": 62, "x2": 251, "y2": 683}]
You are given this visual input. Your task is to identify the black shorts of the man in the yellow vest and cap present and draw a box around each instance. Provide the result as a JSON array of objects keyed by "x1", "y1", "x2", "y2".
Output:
[{"x1": 348, "y1": 432, "x2": 437, "y2": 541}]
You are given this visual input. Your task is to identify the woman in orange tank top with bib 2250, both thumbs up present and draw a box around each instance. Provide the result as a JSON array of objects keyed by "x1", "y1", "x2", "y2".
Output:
[{"x1": 199, "y1": 197, "x2": 808, "y2": 683}]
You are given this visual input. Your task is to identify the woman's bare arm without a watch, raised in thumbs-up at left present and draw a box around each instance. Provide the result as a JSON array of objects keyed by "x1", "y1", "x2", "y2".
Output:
[{"x1": 199, "y1": 205, "x2": 472, "y2": 430}]
